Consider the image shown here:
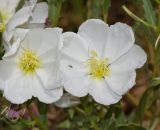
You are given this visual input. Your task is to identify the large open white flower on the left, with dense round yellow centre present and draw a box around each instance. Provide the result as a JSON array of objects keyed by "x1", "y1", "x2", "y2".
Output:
[{"x1": 0, "y1": 28, "x2": 63, "y2": 104}]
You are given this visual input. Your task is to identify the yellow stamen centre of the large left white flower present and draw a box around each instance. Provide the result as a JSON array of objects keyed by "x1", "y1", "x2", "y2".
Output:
[{"x1": 19, "y1": 50, "x2": 40, "y2": 74}]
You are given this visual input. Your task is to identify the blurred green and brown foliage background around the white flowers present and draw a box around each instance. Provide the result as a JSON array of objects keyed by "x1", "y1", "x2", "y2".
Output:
[{"x1": 0, "y1": 0, "x2": 160, "y2": 130}]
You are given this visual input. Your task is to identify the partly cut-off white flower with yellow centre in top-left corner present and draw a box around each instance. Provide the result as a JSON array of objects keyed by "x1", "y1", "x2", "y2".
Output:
[{"x1": 0, "y1": 0, "x2": 20, "y2": 32}]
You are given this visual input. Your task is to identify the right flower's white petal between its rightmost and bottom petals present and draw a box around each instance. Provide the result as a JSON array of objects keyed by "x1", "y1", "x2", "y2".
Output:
[{"x1": 106, "y1": 71, "x2": 136, "y2": 95}]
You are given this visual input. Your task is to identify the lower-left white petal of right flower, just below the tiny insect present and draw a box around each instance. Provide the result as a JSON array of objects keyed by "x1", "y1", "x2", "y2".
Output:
[{"x1": 61, "y1": 59, "x2": 90, "y2": 97}]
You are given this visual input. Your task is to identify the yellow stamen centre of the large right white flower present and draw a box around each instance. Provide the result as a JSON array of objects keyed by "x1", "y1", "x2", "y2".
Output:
[{"x1": 87, "y1": 51, "x2": 110, "y2": 79}]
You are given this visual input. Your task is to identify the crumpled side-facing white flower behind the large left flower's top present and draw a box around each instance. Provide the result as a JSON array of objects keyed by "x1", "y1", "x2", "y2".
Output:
[{"x1": 3, "y1": 0, "x2": 48, "y2": 53}]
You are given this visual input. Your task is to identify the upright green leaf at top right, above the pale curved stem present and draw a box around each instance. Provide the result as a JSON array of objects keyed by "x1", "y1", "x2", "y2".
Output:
[{"x1": 143, "y1": 0, "x2": 156, "y2": 26}]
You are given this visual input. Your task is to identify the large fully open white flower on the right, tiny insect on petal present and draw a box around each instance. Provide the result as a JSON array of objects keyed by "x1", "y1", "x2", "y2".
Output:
[{"x1": 61, "y1": 19, "x2": 147, "y2": 105}]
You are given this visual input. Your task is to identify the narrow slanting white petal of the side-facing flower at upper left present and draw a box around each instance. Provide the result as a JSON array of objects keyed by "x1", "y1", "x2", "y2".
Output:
[{"x1": 6, "y1": 5, "x2": 34, "y2": 32}]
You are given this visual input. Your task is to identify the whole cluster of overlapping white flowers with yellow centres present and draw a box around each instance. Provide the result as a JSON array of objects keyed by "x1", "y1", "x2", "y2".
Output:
[{"x1": 0, "y1": 0, "x2": 147, "y2": 106}]
